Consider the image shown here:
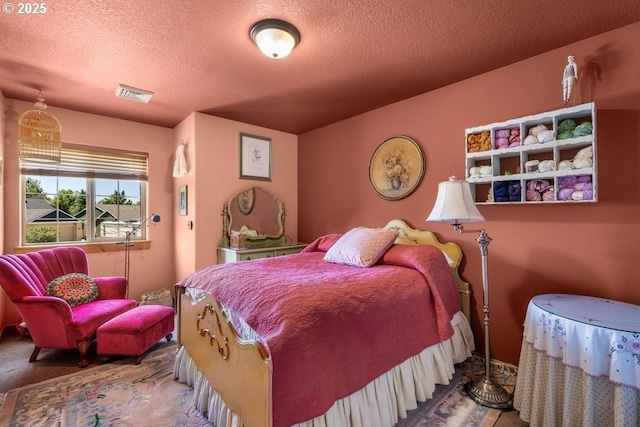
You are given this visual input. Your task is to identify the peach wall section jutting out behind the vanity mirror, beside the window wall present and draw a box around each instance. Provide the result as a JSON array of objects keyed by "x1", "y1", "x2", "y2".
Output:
[{"x1": 173, "y1": 113, "x2": 298, "y2": 280}]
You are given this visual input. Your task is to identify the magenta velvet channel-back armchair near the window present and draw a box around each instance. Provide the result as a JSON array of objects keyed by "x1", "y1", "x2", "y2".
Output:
[{"x1": 0, "y1": 247, "x2": 136, "y2": 367}]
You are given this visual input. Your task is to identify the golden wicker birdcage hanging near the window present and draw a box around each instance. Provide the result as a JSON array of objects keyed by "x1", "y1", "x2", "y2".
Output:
[{"x1": 18, "y1": 93, "x2": 62, "y2": 163}]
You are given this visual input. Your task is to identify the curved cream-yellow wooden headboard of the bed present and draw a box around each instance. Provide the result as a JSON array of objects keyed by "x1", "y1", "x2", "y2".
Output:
[{"x1": 383, "y1": 219, "x2": 471, "y2": 319}]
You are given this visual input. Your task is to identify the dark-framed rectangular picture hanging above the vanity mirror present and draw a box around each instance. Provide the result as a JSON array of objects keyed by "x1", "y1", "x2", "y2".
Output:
[{"x1": 240, "y1": 133, "x2": 271, "y2": 181}]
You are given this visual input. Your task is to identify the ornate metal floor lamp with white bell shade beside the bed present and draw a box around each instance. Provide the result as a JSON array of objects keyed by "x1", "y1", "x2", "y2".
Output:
[{"x1": 427, "y1": 176, "x2": 512, "y2": 409}]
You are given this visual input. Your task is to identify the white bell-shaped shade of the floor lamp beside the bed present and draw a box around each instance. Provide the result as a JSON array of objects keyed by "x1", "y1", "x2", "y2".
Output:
[{"x1": 427, "y1": 176, "x2": 484, "y2": 223}]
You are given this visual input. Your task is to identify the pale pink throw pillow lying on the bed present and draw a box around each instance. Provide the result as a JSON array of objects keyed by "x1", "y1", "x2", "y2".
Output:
[{"x1": 324, "y1": 227, "x2": 398, "y2": 267}]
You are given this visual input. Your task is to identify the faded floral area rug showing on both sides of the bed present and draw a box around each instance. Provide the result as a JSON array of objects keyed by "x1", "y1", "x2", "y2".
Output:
[{"x1": 0, "y1": 345, "x2": 508, "y2": 427}]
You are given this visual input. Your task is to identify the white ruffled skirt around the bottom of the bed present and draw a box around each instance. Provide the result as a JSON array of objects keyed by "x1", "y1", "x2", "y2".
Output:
[{"x1": 173, "y1": 312, "x2": 475, "y2": 427}]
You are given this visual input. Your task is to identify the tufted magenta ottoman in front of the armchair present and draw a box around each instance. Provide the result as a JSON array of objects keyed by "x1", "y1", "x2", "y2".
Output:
[{"x1": 96, "y1": 305, "x2": 175, "y2": 365}]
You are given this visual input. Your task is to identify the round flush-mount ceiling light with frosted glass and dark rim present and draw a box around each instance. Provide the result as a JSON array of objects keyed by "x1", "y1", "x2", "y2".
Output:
[{"x1": 249, "y1": 19, "x2": 300, "y2": 59}]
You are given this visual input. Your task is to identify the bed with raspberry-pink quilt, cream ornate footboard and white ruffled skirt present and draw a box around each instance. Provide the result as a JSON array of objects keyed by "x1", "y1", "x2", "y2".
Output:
[{"x1": 174, "y1": 219, "x2": 474, "y2": 427}]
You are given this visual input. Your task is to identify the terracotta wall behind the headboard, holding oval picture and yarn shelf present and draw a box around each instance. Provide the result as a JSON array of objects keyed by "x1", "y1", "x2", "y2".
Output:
[{"x1": 298, "y1": 23, "x2": 640, "y2": 364}]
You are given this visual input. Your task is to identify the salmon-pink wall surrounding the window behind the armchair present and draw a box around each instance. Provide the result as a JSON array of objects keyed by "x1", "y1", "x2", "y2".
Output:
[{"x1": 0, "y1": 99, "x2": 174, "y2": 325}]
